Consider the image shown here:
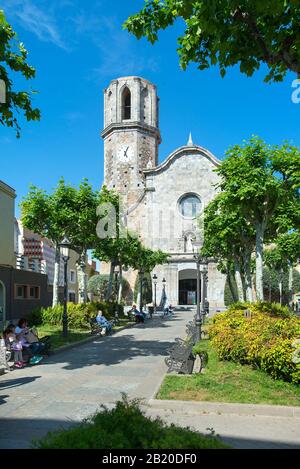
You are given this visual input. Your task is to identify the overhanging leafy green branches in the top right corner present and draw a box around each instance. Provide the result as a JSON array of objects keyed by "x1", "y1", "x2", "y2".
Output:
[{"x1": 124, "y1": 0, "x2": 300, "y2": 81}]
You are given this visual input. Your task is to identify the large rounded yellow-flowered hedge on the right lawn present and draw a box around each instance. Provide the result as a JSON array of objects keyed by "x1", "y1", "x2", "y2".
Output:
[{"x1": 209, "y1": 303, "x2": 300, "y2": 384}]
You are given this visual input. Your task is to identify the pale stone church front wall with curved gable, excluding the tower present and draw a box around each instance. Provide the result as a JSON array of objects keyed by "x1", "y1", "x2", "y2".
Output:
[{"x1": 128, "y1": 146, "x2": 225, "y2": 308}]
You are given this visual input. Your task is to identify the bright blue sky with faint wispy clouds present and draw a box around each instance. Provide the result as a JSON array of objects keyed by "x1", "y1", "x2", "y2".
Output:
[{"x1": 0, "y1": 0, "x2": 300, "y2": 213}]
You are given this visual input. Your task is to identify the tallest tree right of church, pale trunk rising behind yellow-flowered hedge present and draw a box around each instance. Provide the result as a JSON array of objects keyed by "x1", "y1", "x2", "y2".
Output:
[{"x1": 217, "y1": 137, "x2": 300, "y2": 300}]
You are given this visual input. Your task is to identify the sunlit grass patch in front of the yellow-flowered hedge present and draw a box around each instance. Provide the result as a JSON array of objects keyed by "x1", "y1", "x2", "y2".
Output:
[{"x1": 156, "y1": 340, "x2": 300, "y2": 406}]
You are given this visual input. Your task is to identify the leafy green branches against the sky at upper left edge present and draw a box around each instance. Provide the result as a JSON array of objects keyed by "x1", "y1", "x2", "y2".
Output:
[{"x1": 0, "y1": 10, "x2": 40, "y2": 138}]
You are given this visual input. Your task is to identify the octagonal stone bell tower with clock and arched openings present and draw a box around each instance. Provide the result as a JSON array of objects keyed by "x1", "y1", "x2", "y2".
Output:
[{"x1": 101, "y1": 77, "x2": 161, "y2": 206}]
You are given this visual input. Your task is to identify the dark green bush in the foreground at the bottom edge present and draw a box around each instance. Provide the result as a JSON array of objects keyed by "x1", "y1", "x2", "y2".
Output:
[{"x1": 34, "y1": 399, "x2": 228, "y2": 449}]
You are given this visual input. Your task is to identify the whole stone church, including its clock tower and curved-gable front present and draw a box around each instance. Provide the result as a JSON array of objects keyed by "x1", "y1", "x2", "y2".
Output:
[{"x1": 101, "y1": 77, "x2": 225, "y2": 309}]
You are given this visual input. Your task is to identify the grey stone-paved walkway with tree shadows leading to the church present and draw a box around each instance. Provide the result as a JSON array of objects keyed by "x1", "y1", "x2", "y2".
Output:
[{"x1": 0, "y1": 311, "x2": 300, "y2": 448}]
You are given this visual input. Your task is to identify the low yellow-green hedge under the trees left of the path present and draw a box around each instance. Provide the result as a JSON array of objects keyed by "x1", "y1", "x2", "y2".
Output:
[{"x1": 28, "y1": 302, "x2": 124, "y2": 329}]
